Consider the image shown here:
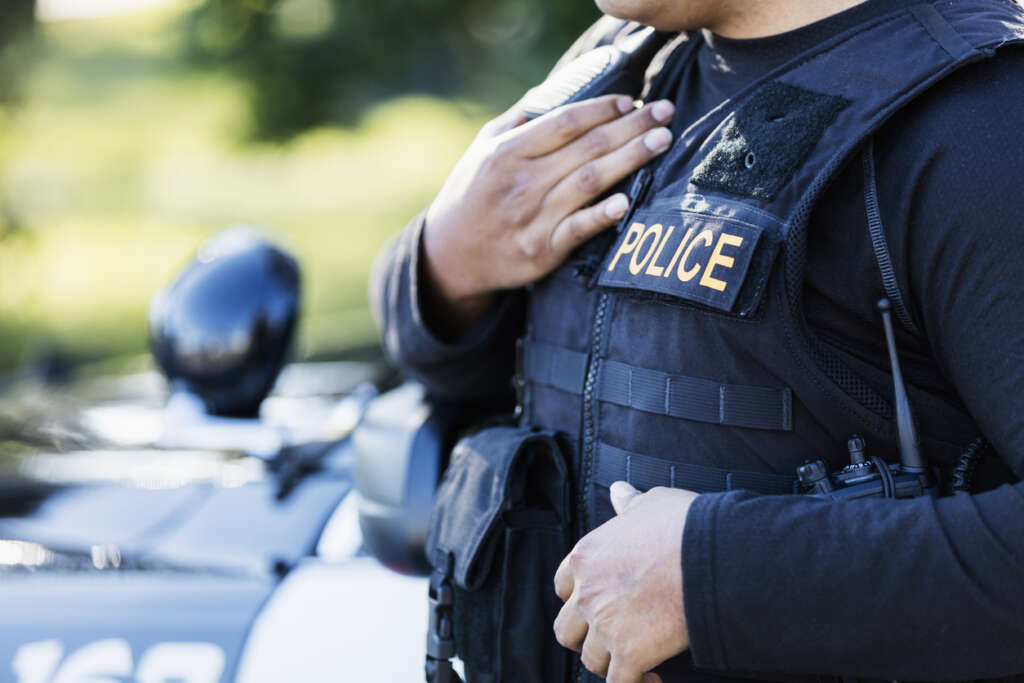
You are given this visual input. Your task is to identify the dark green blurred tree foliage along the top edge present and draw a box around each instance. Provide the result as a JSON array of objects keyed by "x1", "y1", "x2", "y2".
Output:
[{"x1": 187, "y1": 0, "x2": 598, "y2": 139}]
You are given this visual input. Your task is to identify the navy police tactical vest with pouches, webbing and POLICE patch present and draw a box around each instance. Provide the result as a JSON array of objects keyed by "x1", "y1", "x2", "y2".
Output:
[{"x1": 428, "y1": 0, "x2": 1024, "y2": 682}]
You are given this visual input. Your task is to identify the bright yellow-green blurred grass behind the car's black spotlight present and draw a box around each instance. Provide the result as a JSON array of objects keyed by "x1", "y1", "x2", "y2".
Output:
[{"x1": 0, "y1": 2, "x2": 487, "y2": 368}]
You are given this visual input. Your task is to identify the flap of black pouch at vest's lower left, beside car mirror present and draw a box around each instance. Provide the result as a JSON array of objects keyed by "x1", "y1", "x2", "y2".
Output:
[{"x1": 426, "y1": 427, "x2": 568, "y2": 591}]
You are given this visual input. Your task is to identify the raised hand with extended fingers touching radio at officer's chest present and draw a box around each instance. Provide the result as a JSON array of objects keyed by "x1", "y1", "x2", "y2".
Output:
[{"x1": 423, "y1": 95, "x2": 675, "y2": 327}]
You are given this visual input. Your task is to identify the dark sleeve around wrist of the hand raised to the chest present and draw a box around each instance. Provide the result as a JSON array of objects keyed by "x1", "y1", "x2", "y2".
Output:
[{"x1": 370, "y1": 214, "x2": 523, "y2": 410}]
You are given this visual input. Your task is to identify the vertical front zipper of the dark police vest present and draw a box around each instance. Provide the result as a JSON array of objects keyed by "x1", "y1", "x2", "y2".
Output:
[{"x1": 573, "y1": 168, "x2": 651, "y2": 683}]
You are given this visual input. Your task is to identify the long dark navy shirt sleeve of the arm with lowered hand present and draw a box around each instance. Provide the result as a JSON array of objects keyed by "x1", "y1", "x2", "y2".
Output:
[{"x1": 682, "y1": 51, "x2": 1024, "y2": 680}]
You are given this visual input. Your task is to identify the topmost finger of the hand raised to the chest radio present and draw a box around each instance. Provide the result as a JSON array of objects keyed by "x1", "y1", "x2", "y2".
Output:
[{"x1": 515, "y1": 95, "x2": 633, "y2": 157}]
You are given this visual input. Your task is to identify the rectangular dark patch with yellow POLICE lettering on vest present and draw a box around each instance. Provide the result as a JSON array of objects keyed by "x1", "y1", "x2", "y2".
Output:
[{"x1": 598, "y1": 212, "x2": 764, "y2": 311}]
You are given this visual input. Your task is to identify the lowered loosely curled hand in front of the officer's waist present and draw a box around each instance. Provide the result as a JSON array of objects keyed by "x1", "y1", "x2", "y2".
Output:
[{"x1": 554, "y1": 481, "x2": 697, "y2": 683}]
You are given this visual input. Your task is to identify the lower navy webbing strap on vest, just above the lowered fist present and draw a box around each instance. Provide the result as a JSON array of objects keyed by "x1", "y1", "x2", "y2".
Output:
[{"x1": 594, "y1": 443, "x2": 796, "y2": 495}]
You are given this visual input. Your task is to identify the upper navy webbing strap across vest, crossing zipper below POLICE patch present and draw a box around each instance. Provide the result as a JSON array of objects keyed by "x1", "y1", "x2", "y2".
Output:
[{"x1": 521, "y1": 340, "x2": 793, "y2": 431}]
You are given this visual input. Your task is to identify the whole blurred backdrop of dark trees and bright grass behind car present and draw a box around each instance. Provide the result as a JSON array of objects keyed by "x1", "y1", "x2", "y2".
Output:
[{"x1": 0, "y1": 0, "x2": 597, "y2": 371}]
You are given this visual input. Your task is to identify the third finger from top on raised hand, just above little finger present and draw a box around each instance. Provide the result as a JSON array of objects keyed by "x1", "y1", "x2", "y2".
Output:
[{"x1": 545, "y1": 128, "x2": 672, "y2": 215}]
